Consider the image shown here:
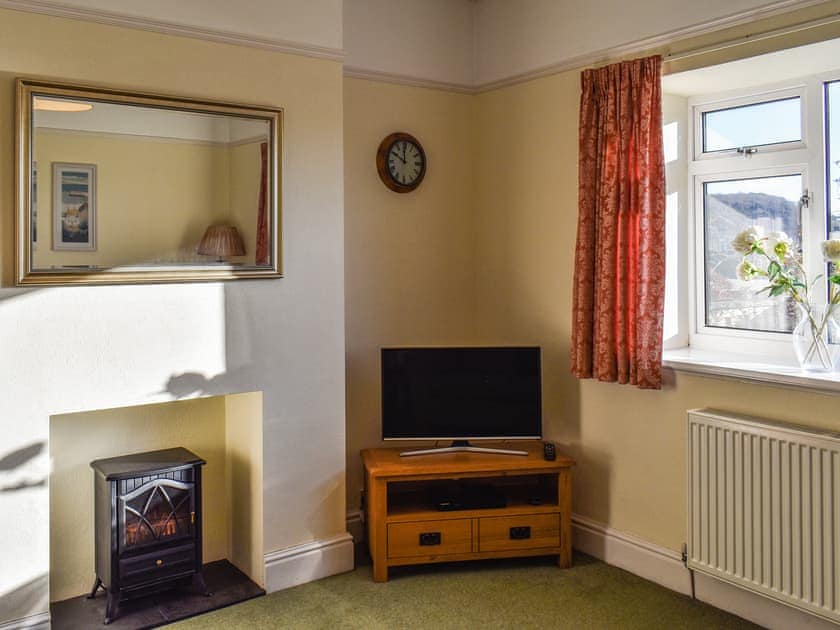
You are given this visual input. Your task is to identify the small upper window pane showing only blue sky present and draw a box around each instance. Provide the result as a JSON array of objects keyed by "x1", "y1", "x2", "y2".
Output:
[{"x1": 703, "y1": 96, "x2": 802, "y2": 153}]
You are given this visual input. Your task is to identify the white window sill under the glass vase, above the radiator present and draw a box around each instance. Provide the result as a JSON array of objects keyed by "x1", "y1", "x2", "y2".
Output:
[{"x1": 662, "y1": 348, "x2": 840, "y2": 394}]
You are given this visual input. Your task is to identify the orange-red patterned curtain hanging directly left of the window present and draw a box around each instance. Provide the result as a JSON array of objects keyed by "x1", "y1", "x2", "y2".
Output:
[{"x1": 572, "y1": 56, "x2": 665, "y2": 389}]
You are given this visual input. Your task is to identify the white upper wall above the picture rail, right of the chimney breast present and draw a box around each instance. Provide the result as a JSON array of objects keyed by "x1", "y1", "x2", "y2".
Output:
[{"x1": 344, "y1": 0, "x2": 815, "y2": 89}]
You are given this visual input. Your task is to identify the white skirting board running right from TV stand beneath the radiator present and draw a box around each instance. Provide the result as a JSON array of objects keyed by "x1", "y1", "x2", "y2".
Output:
[{"x1": 572, "y1": 514, "x2": 837, "y2": 630}]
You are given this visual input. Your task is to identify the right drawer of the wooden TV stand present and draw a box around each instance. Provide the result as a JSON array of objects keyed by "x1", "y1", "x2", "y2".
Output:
[{"x1": 478, "y1": 514, "x2": 560, "y2": 551}]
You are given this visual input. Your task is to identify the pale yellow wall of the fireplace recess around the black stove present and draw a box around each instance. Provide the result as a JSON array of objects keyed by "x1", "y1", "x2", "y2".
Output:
[{"x1": 50, "y1": 397, "x2": 231, "y2": 601}]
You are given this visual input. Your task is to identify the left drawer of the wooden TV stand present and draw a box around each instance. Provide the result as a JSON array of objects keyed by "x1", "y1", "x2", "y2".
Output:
[{"x1": 388, "y1": 518, "x2": 472, "y2": 558}]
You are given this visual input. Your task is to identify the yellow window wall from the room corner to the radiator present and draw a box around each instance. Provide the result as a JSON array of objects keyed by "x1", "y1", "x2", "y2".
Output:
[{"x1": 466, "y1": 18, "x2": 840, "y2": 550}]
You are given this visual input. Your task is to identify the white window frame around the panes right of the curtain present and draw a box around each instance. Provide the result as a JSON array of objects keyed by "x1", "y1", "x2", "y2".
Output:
[{"x1": 686, "y1": 76, "x2": 840, "y2": 361}]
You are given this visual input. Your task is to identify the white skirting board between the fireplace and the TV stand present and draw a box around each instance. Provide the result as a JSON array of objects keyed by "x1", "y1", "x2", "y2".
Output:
[{"x1": 262, "y1": 532, "x2": 353, "y2": 596}]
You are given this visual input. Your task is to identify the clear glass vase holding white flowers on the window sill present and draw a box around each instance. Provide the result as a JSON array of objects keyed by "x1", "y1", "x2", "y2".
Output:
[{"x1": 793, "y1": 304, "x2": 840, "y2": 372}]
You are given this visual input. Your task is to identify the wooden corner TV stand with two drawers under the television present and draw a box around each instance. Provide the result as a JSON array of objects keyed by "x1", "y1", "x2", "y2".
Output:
[{"x1": 362, "y1": 442, "x2": 575, "y2": 582}]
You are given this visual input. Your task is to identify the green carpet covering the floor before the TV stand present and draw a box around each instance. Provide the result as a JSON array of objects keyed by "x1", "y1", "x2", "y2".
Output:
[{"x1": 173, "y1": 554, "x2": 758, "y2": 630}]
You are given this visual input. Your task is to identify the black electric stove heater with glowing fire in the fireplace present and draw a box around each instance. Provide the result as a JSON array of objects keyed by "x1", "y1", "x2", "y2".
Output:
[{"x1": 90, "y1": 448, "x2": 207, "y2": 624}]
